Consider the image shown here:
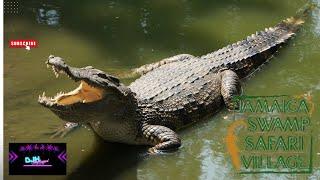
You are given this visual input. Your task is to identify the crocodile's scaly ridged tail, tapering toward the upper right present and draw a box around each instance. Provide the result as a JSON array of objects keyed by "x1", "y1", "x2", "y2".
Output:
[{"x1": 201, "y1": 4, "x2": 314, "y2": 78}]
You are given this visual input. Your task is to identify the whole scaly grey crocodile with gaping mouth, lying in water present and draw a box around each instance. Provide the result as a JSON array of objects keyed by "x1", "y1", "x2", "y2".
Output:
[{"x1": 38, "y1": 8, "x2": 310, "y2": 153}]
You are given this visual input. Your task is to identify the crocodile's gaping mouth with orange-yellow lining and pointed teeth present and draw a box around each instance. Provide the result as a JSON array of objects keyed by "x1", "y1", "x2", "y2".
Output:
[{"x1": 38, "y1": 64, "x2": 105, "y2": 107}]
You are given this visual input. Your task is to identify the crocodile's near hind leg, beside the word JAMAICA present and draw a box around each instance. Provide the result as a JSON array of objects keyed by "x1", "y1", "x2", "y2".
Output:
[{"x1": 221, "y1": 70, "x2": 241, "y2": 110}]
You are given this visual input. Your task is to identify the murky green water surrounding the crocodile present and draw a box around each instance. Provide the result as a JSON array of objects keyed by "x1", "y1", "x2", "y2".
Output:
[{"x1": 4, "y1": 0, "x2": 320, "y2": 179}]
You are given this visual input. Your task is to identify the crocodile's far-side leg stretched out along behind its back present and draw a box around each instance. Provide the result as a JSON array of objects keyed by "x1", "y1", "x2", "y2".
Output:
[{"x1": 132, "y1": 54, "x2": 194, "y2": 75}]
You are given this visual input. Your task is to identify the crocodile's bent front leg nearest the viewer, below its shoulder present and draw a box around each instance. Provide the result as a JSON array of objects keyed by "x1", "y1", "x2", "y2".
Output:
[{"x1": 142, "y1": 124, "x2": 181, "y2": 154}]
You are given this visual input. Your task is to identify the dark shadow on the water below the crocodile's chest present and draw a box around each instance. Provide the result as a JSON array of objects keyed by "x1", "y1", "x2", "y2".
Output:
[{"x1": 68, "y1": 136, "x2": 141, "y2": 180}]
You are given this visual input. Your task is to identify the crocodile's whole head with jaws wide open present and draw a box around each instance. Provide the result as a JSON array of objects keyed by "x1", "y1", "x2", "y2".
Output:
[{"x1": 38, "y1": 56, "x2": 131, "y2": 123}]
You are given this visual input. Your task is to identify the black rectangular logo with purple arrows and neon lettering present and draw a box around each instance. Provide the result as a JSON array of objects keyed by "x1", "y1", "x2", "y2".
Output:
[{"x1": 8, "y1": 143, "x2": 67, "y2": 175}]
